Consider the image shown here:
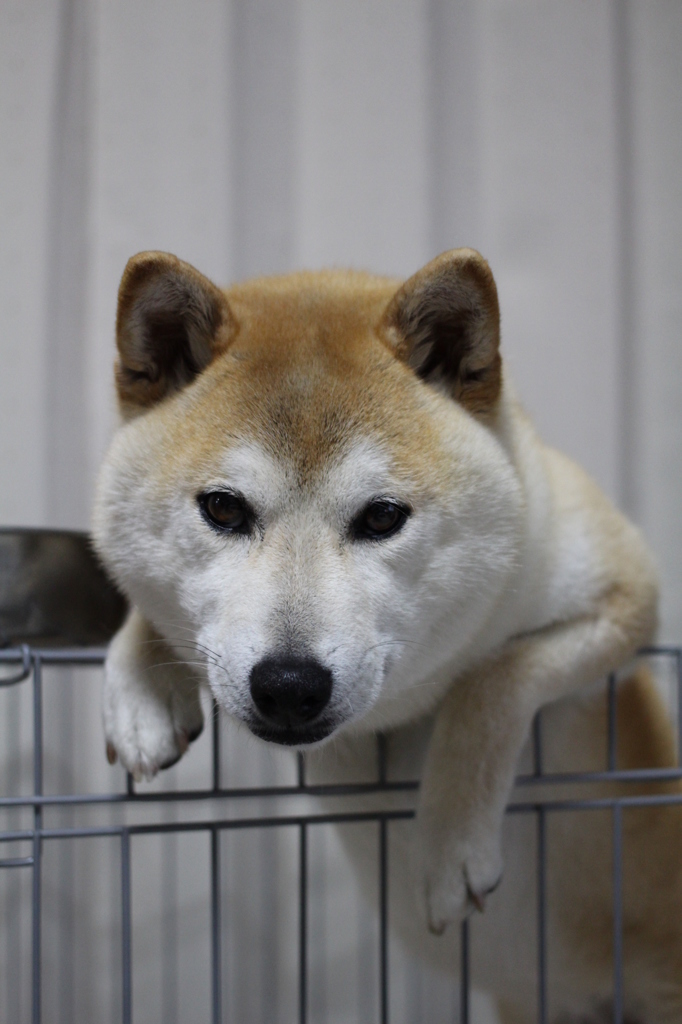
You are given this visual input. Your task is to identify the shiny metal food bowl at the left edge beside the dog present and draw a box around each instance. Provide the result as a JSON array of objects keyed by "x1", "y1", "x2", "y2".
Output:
[{"x1": 0, "y1": 528, "x2": 127, "y2": 647}]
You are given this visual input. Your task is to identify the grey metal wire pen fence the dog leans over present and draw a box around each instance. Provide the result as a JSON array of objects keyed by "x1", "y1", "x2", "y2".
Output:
[{"x1": 0, "y1": 646, "x2": 682, "y2": 1024}]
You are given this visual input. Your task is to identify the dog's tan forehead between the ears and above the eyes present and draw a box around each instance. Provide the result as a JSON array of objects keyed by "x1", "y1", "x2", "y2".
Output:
[{"x1": 166, "y1": 274, "x2": 448, "y2": 486}]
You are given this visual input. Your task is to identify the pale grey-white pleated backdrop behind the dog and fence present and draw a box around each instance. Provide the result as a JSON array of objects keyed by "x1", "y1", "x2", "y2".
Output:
[{"x1": 0, "y1": 0, "x2": 682, "y2": 1024}]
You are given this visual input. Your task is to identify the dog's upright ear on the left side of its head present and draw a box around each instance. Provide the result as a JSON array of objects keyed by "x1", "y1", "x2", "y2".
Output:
[{"x1": 116, "y1": 252, "x2": 237, "y2": 415}]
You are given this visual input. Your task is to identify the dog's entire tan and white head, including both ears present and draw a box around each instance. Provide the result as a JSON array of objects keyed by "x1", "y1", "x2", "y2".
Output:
[{"x1": 94, "y1": 250, "x2": 521, "y2": 744}]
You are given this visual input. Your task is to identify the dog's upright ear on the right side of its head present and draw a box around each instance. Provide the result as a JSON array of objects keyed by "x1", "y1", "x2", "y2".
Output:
[{"x1": 381, "y1": 249, "x2": 502, "y2": 415}]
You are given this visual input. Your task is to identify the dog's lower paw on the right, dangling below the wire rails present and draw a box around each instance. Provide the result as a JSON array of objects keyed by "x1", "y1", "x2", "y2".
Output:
[{"x1": 411, "y1": 823, "x2": 503, "y2": 935}]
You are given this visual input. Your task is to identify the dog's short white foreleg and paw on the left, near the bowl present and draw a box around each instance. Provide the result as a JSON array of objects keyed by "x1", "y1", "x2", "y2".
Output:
[{"x1": 103, "y1": 608, "x2": 204, "y2": 780}]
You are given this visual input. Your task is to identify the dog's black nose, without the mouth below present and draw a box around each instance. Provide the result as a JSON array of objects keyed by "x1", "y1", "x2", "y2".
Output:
[{"x1": 251, "y1": 657, "x2": 332, "y2": 729}]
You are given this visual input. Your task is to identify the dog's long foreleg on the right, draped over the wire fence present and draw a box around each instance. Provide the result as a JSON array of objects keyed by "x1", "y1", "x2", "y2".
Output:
[{"x1": 418, "y1": 587, "x2": 655, "y2": 934}]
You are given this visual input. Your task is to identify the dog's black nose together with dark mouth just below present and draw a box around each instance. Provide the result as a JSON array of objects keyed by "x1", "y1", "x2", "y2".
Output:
[{"x1": 249, "y1": 656, "x2": 333, "y2": 746}]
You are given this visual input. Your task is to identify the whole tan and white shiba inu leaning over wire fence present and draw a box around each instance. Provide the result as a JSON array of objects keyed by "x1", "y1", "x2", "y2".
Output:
[{"x1": 94, "y1": 249, "x2": 682, "y2": 1021}]
